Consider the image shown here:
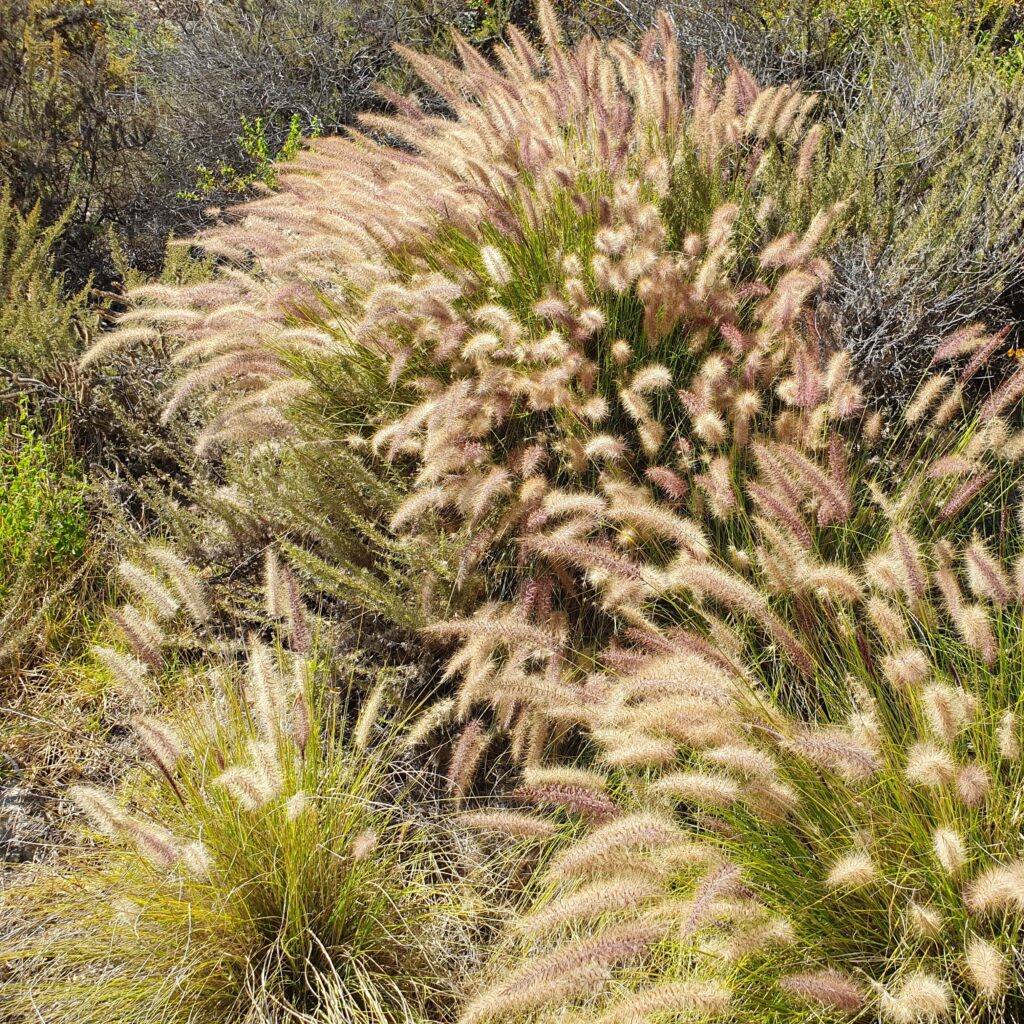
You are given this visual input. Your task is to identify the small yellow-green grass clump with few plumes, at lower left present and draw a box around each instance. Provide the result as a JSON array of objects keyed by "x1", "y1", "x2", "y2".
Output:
[{"x1": 5, "y1": 626, "x2": 487, "y2": 1024}]
